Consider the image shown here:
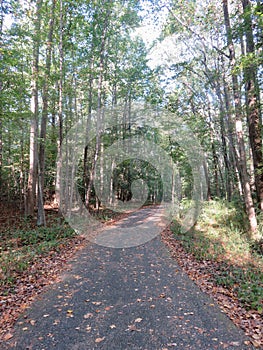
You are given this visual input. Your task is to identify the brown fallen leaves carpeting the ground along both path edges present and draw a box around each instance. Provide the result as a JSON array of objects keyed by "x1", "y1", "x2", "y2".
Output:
[{"x1": 0, "y1": 201, "x2": 263, "y2": 348}]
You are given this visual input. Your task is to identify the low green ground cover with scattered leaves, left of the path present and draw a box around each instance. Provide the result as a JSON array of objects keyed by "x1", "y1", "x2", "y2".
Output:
[{"x1": 0, "y1": 223, "x2": 76, "y2": 293}]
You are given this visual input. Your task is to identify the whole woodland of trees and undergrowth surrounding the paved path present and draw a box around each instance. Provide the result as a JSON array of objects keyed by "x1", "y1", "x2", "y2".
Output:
[{"x1": 0, "y1": 0, "x2": 263, "y2": 346}]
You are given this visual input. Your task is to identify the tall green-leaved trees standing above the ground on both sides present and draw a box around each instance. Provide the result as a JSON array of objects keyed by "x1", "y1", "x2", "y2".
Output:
[{"x1": 0, "y1": 0, "x2": 263, "y2": 238}]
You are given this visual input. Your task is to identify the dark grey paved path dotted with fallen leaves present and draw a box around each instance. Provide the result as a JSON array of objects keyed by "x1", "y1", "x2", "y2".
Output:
[{"x1": 6, "y1": 209, "x2": 253, "y2": 350}]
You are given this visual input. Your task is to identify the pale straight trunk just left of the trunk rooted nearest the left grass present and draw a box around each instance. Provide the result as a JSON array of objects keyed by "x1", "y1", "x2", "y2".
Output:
[{"x1": 26, "y1": 0, "x2": 43, "y2": 216}]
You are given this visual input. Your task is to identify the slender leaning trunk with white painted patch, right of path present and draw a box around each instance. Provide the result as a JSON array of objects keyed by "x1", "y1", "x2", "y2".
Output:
[{"x1": 223, "y1": 0, "x2": 257, "y2": 238}]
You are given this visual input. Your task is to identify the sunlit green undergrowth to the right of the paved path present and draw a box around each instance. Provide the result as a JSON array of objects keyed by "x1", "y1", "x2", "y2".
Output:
[{"x1": 172, "y1": 200, "x2": 263, "y2": 313}]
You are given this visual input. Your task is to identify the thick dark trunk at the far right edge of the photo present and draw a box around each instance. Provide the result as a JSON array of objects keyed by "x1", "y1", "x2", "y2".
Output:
[{"x1": 241, "y1": 0, "x2": 263, "y2": 210}]
